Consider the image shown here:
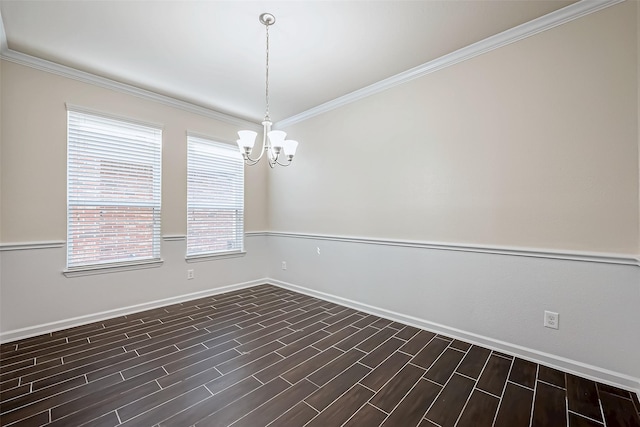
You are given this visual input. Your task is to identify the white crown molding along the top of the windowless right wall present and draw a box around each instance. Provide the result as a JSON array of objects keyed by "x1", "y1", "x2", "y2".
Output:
[{"x1": 274, "y1": 0, "x2": 625, "y2": 128}]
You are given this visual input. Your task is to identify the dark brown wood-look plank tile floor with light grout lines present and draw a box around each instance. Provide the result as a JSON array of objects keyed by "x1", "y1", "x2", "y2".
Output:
[{"x1": 0, "y1": 285, "x2": 640, "y2": 427}]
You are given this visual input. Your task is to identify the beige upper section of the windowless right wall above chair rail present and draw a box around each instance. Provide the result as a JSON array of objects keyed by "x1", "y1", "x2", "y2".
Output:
[{"x1": 269, "y1": 1, "x2": 639, "y2": 254}]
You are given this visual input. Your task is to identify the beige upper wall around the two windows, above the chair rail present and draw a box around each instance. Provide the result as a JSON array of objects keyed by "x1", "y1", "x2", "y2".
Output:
[{"x1": 1, "y1": 61, "x2": 267, "y2": 243}]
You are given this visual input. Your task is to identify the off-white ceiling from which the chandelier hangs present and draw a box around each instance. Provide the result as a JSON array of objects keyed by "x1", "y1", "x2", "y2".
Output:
[{"x1": 0, "y1": 0, "x2": 575, "y2": 122}]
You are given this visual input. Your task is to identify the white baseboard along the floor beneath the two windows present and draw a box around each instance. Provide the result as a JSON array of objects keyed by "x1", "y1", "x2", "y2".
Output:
[{"x1": 0, "y1": 279, "x2": 268, "y2": 344}]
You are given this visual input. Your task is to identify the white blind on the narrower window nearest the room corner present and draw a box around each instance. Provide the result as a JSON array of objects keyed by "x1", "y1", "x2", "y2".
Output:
[{"x1": 187, "y1": 135, "x2": 244, "y2": 256}]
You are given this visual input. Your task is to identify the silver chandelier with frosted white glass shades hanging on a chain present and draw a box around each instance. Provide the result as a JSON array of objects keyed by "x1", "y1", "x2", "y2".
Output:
[{"x1": 238, "y1": 13, "x2": 298, "y2": 168}]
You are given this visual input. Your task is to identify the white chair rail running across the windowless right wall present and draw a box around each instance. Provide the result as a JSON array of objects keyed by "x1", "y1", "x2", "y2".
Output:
[{"x1": 265, "y1": 232, "x2": 640, "y2": 266}]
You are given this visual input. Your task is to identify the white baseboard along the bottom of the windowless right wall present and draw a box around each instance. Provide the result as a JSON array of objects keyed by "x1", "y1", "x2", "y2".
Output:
[{"x1": 266, "y1": 279, "x2": 640, "y2": 398}]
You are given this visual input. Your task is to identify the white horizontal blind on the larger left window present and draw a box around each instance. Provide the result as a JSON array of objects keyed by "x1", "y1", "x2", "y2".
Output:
[{"x1": 67, "y1": 110, "x2": 162, "y2": 269}]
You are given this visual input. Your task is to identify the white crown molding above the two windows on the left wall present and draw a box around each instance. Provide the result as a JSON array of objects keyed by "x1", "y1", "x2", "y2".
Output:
[{"x1": 0, "y1": 48, "x2": 262, "y2": 131}]
